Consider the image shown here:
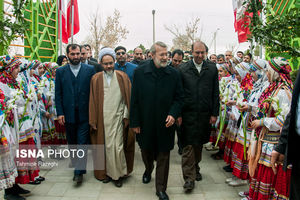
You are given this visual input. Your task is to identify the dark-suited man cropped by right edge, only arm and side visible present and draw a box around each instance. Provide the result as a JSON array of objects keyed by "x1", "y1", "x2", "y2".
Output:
[{"x1": 271, "y1": 74, "x2": 300, "y2": 200}]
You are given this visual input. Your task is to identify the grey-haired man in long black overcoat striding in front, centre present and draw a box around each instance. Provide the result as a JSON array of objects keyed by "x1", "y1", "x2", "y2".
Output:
[{"x1": 130, "y1": 42, "x2": 183, "y2": 200}]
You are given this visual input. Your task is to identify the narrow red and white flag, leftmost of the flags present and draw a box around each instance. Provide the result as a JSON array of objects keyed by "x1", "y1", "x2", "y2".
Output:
[{"x1": 58, "y1": 0, "x2": 68, "y2": 44}]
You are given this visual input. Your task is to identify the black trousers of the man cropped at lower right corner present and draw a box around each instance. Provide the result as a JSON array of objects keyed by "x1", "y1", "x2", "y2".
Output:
[{"x1": 290, "y1": 160, "x2": 300, "y2": 200}]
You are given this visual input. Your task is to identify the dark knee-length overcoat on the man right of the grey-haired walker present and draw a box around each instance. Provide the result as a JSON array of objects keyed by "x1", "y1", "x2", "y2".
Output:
[{"x1": 179, "y1": 60, "x2": 220, "y2": 146}]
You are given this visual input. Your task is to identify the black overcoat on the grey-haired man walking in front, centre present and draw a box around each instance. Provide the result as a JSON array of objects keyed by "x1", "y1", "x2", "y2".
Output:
[{"x1": 130, "y1": 60, "x2": 183, "y2": 152}]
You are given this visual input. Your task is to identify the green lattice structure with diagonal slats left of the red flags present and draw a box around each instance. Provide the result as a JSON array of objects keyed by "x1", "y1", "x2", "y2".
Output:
[{"x1": 0, "y1": 0, "x2": 58, "y2": 62}]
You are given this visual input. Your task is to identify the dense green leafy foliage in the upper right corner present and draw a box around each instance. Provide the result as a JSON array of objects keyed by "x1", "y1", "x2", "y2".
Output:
[{"x1": 246, "y1": 0, "x2": 300, "y2": 58}]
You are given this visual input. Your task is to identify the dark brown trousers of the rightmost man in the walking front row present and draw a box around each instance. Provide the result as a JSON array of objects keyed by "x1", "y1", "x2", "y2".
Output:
[{"x1": 181, "y1": 145, "x2": 203, "y2": 181}]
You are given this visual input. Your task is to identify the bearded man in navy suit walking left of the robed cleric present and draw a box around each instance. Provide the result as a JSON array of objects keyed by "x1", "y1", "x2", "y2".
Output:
[{"x1": 55, "y1": 44, "x2": 95, "y2": 184}]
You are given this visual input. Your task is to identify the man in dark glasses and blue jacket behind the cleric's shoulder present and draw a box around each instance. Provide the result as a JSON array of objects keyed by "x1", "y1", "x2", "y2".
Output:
[{"x1": 115, "y1": 46, "x2": 136, "y2": 83}]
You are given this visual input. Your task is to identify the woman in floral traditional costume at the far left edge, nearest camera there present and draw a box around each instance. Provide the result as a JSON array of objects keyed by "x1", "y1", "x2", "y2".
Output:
[{"x1": 0, "y1": 56, "x2": 39, "y2": 199}]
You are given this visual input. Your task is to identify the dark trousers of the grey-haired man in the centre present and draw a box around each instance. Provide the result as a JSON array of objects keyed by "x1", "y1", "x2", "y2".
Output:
[{"x1": 141, "y1": 150, "x2": 170, "y2": 192}]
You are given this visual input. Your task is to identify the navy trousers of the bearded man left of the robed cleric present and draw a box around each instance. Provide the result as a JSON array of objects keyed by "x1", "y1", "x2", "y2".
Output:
[{"x1": 65, "y1": 109, "x2": 90, "y2": 175}]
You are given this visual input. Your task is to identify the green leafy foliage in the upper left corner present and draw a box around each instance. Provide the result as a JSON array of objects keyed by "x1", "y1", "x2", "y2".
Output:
[{"x1": 0, "y1": 0, "x2": 28, "y2": 54}]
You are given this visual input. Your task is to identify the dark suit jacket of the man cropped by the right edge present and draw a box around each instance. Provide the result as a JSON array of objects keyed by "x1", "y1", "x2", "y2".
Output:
[{"x1": 275, "y1": 73, "x2": 300, "y2": 169}]
